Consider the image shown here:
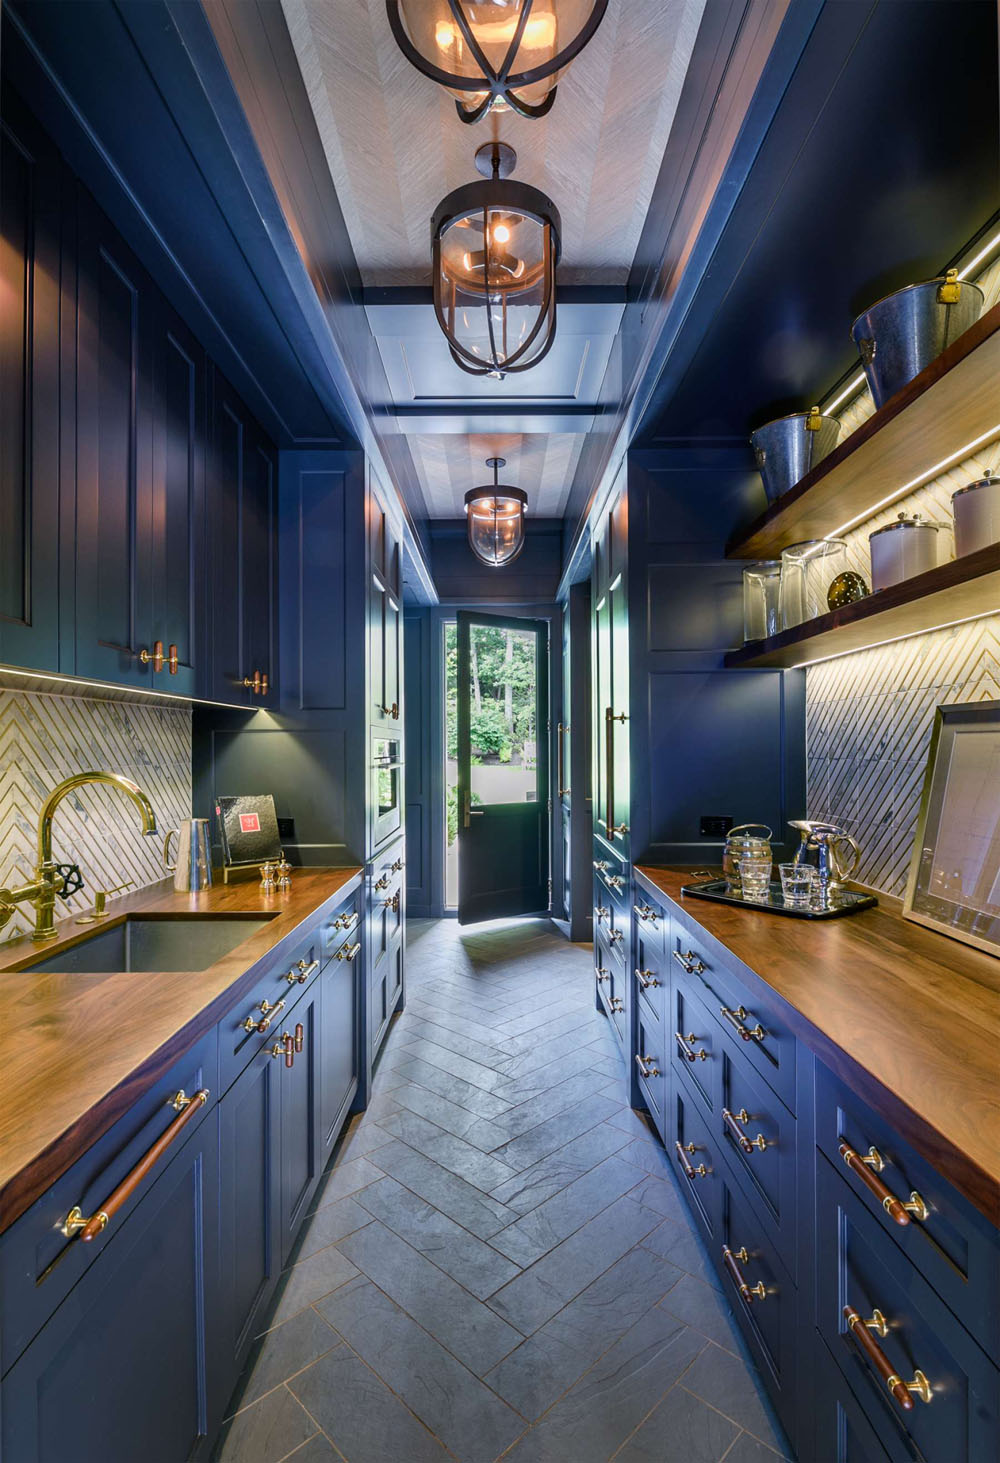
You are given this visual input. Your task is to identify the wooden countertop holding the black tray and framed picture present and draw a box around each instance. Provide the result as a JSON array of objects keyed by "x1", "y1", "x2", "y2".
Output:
[{"x1": 636, "y1": 865, "x2": 1000, "y2": 1226}]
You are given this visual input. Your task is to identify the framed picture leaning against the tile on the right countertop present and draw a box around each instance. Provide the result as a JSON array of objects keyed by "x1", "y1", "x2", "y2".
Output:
[{"x1": 904, "y1": 701, "x2": 1000, "y2": 955}]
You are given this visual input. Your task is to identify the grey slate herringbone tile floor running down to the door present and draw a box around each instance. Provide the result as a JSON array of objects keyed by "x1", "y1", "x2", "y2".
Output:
[{"x1": 219, "y1": 920, "x2": 785, "y2": 1463}]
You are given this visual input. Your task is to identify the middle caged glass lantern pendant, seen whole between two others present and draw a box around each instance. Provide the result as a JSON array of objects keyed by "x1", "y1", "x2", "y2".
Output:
[{"x1": 431, "y1": 142, "x2": 560, "y2": 380}]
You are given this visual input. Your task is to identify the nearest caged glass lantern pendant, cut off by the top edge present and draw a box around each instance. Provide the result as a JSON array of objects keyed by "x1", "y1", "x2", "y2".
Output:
[{"x1": 386, "y1": 0, "x2": 608, "y2": 121}]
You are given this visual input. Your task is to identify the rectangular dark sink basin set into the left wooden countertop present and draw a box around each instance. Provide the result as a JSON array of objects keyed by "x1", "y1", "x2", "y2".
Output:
[{"x1": 22, "y1": 914, "x2": 275, "y2": 974}]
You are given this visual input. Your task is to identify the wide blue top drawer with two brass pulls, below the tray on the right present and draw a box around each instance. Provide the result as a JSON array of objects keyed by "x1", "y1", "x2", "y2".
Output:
[{"x1": 670, "y1": 917, "x2": 795, "y2": 1112}]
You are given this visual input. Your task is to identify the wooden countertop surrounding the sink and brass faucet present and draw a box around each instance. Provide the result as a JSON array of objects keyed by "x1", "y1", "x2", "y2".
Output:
[{"x1": 0, "y1": 866, "x2": 361, "y2": 1232}]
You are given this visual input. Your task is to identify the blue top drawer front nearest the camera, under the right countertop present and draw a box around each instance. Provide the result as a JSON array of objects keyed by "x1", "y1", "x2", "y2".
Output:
[{"x1": 816, "y1": 1062, "x2": 1000, "y2": 1356}]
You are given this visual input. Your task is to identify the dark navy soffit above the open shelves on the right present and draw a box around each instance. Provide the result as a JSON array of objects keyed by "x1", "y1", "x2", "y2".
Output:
[{"x1": 642, "y1": 0, "x2": 1000, "y2": 446}]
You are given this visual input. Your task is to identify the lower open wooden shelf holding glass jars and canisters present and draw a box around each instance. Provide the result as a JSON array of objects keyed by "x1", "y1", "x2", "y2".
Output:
[{"x1": 725, "y1": 544, "x2": 1000, "y2": 669}]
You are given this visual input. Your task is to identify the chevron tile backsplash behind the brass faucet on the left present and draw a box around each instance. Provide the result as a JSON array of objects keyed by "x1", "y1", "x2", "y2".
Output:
[{"x1": 0, "y1": 691, "x2": 192, "y2": 939}]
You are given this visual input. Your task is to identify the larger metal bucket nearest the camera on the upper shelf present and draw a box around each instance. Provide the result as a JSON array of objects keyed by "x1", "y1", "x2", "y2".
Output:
[{"x1": 851, "y1": 269, "x2": 984, "y2": 407}]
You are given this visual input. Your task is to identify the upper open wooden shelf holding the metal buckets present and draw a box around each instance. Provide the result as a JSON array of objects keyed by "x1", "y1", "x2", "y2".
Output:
[{"x1": 727, "y1": 304, "x2": 1000, "y2": 559}]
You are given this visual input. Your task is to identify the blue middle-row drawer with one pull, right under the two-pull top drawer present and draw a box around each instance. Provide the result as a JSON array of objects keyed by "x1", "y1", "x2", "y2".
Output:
[{"x1": 716, "y1": 1037, "x2": 797, "y2": 1279}]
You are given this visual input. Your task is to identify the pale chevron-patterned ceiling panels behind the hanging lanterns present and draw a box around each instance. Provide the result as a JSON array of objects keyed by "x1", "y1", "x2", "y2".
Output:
[{"x1": 282, "y1": 0, "x2": 705, "y2": 518}]
